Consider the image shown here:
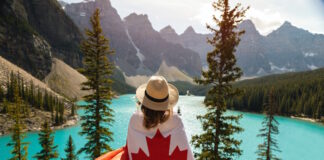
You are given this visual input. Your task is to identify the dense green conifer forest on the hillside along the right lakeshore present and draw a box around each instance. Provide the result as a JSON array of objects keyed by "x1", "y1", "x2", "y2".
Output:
[{"x1": 228, "y1": 68, "x2": 324, "y2": 119}]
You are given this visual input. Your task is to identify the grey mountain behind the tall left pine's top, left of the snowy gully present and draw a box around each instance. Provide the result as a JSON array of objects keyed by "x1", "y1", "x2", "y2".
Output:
[{"x1": 65, "y1": 0, "x2": 140, "y2": 74}]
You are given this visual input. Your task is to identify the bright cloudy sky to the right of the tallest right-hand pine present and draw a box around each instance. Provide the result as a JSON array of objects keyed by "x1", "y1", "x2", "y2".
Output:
[{"x1": 238, "y1": 0, "x2": 324, "y2": 35}]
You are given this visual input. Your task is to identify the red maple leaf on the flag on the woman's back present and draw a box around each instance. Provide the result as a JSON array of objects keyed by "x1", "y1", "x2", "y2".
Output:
[{"x1": 132, "y1": 130, "x2": 188, "y2": 160}]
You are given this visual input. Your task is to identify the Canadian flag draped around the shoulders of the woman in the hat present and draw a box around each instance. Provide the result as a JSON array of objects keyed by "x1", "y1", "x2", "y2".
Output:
[{"x1": 97, "y1": 111, "x2": 194, "y2": 160}]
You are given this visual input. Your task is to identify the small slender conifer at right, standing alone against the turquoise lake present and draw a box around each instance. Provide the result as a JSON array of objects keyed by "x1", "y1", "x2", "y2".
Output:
[{"x1": 256, "y1": 89, "x2": 280, "y2": 160}]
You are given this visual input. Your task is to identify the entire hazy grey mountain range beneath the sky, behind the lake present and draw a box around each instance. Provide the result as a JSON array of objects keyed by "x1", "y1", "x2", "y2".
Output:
[{"x1": 63, "y1": 0, "x2": 324, "y2": 77}]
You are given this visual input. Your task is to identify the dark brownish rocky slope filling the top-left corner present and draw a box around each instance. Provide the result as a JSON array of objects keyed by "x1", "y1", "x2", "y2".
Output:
[{"x1": 0, "y1": 0, "x2": 51, "y2": 78}]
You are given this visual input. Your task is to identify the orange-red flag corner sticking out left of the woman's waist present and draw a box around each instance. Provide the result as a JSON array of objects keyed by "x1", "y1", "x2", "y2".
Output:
[{"x1": 96, "y1": 147, "x2": 128, "y2": 160}]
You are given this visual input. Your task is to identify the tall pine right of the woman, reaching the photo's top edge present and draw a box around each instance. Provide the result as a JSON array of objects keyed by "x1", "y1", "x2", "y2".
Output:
[{"x1": 192, "y1": 0, "x2": 248, "y2": 160}]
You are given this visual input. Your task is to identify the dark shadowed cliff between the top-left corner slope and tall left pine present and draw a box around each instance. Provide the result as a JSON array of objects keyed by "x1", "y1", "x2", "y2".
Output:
[{"x1": 24, "y1": 0, "x2": 83, "y2": 67}]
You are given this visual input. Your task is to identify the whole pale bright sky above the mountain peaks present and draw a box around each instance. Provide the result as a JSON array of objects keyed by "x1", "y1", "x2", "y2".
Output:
[{"x1": 64, "y1": 0, "x2": 324, "y2": 35}]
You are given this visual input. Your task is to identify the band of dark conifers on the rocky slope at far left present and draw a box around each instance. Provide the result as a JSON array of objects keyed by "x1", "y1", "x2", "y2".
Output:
[{"x1": 0, "y1": 72, "x2": 65, "y2": 125}]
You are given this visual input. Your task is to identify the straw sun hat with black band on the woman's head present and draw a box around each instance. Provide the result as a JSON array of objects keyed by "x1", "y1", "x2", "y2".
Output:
[{"x1": 136, "y1": 76, "x2": 179, "y2": 111}]
